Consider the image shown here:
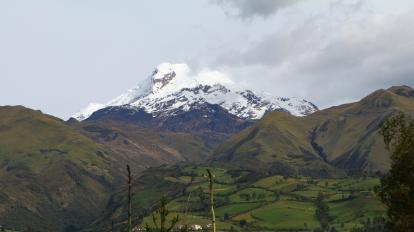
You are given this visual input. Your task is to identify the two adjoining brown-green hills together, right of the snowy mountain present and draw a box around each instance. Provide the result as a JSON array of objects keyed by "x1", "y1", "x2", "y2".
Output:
[{"x1": 211, "y1": 86, "x2": 414, "y2": 176}]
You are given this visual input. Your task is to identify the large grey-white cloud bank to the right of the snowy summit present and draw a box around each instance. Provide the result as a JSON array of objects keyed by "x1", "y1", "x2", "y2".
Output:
[{"x1": 212, "y1": 1, "x2": 414, "y2": 107}]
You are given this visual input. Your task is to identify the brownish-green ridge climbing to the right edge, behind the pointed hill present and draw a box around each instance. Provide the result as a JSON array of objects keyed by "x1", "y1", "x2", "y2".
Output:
[{"x1": 310, "y1": 90, "x2": 414, "y2": 171}]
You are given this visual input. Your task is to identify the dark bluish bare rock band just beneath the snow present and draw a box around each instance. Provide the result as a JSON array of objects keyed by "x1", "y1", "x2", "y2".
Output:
[{"x1": 85, "y1": 103, "x2": 254, "y2": 146}]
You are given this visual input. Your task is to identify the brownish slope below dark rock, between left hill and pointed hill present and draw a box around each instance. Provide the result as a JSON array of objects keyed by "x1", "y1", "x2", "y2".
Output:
[{"x1": 69, "y1": 121, "x2": 212, "y2": 171}]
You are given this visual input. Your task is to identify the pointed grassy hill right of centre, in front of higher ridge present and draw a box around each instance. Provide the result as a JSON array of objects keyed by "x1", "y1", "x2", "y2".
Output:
[{"x1": 213, "y1": 112, "x2": 342, "y2": 176}]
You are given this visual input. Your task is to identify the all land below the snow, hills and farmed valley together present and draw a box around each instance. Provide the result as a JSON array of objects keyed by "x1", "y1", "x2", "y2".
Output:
[{"x1": 0, "y1": 78, "x2": 414, "y2": 232}]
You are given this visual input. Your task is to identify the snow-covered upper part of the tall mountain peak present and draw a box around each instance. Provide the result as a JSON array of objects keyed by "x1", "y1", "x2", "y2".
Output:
[{"x1": 73, "y1": 63, "x2": 317, "y2": 121}]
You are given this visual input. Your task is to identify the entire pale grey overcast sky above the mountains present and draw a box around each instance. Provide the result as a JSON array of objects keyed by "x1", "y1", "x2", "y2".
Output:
[{"x1": 0, "y1": 0, "x2": 414, "y2": 119}]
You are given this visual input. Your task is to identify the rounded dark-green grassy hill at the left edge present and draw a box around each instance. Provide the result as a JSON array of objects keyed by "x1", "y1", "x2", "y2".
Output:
[{"x1": 0, "y1": 107, "x2": 114, "y2": 231}]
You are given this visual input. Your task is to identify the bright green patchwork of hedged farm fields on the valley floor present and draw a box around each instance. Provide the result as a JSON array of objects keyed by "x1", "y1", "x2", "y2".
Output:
[{"x1": 141, "y1": 167, "x2": 385, "y2": 231}]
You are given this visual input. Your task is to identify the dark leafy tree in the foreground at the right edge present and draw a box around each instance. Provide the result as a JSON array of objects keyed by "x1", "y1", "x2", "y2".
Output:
[{"x1": 376, "y1": 113, "x2": 414, "y2": 231}]
